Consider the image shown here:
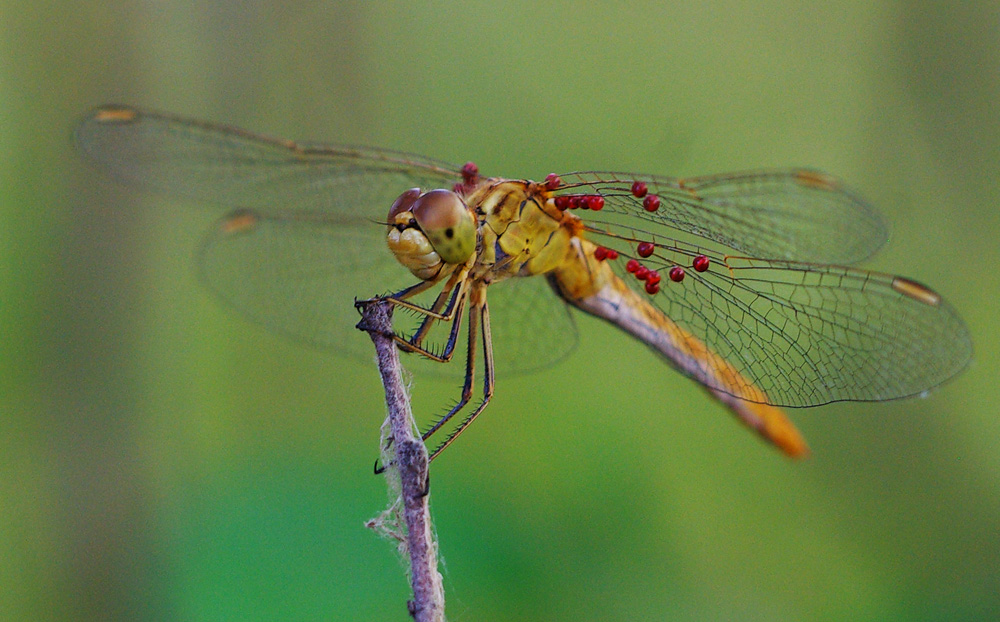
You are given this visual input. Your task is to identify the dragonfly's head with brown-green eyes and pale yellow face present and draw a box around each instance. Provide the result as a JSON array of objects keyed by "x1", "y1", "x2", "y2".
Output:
[{"x1": 387, "y1": 188, "x2": 476, "y2": 279}]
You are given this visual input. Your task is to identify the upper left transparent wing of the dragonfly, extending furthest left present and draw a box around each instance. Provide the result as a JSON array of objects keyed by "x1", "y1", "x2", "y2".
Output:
[{"x1": 76, "y1": 106, "x2": 461, "y2": 222}]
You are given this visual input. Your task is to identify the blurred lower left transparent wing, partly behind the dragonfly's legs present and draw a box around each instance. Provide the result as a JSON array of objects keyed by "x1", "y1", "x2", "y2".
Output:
[{"x1": 198, "y1": 209, "x2": 577, "y2": 376}]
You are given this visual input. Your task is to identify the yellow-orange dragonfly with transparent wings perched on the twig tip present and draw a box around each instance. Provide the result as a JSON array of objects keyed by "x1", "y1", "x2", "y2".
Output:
[{"x1": 75, "y1": 105, "x2": 972, "y2": 458}]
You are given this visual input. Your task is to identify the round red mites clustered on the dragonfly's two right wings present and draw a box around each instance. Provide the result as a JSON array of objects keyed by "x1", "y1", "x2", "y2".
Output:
[{"x1": 545, "y1": 173, "x2": 710, "y2": 295}]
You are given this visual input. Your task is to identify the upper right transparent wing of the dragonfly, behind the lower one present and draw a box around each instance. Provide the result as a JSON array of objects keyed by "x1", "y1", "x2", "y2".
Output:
[{"x1": 560, "y1": 169, "x2": 888, "y2": 264}]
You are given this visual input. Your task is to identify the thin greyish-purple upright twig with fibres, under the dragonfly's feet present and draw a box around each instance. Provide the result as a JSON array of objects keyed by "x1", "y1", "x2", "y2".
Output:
[{"x1": 357, "y1": 301, "x2": 444, "y2": 622}]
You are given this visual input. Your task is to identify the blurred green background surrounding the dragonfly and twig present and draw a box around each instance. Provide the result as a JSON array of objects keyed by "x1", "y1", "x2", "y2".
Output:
[{"x1": 0, "y1": 0, "x2": 1000, "y2": 621}]
